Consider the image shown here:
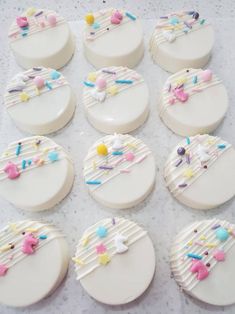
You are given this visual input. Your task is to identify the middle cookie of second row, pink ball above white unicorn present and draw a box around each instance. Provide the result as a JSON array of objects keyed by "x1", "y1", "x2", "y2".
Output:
[{"x1": 83, "y1": 67, "x2": 149, "y2": 134}]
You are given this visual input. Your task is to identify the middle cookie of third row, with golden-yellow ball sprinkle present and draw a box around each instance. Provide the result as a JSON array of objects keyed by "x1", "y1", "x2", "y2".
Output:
[{"x1": 83, "y1": 134, "x2": 155, "y2": 209}]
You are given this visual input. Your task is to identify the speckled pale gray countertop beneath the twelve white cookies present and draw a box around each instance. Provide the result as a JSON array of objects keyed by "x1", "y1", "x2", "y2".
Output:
[{"x1": 0, "y1": 0, "x2": 235, "y2": 314}]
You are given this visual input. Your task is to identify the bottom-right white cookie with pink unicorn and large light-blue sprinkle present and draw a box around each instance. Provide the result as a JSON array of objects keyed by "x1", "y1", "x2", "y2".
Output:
[{"x1": 170, "y1": 219, "x2": 235, "y2": 306}]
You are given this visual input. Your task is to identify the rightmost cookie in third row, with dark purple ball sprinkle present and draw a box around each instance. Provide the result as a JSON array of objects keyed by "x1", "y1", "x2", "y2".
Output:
[{"x1": 164, "y1": 134, "x2": 235, "y2": 209}]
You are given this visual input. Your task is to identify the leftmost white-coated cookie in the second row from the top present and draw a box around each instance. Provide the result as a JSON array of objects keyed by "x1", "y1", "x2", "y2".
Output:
[{"x1": 4, "y1": 67, "x2": 76, "y2": 135}]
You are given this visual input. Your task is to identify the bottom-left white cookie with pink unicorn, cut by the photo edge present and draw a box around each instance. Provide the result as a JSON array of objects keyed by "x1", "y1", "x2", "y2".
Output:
[{"x1": 0, "y1": 220, "x2": 69, "y2": 307}]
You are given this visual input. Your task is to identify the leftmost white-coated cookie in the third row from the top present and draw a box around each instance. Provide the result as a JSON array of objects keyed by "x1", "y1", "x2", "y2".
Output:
[{"x1": 0, "y1": 136, "x2": 74, "y2": 211}]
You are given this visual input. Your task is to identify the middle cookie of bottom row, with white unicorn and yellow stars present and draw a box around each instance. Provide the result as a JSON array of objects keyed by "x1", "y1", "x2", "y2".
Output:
[{"x1": 73, "y1": 218, "x2": 155, "y2": 305}]
